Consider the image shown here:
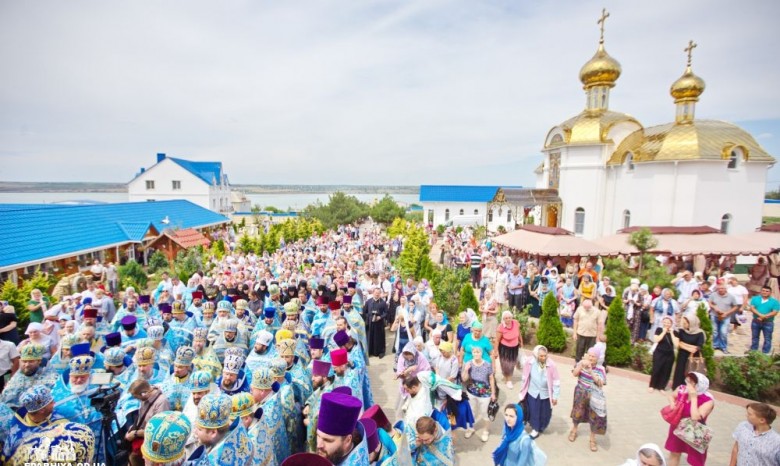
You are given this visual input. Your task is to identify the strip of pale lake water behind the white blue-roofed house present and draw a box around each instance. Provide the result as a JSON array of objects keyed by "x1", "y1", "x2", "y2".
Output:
[{"x1": 0, "y1": 192, "x2": 419, "y2": 210}]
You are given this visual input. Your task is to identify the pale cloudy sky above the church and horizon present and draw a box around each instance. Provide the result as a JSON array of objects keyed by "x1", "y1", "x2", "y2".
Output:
[{"x1": 0, "y1": 0, "x2": 780, "y2": 186}]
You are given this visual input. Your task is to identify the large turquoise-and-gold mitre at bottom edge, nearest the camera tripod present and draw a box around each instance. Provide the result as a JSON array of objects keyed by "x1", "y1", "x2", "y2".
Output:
[{"x1": 141, "y1": 411, "x2": 192, "y2": 464}]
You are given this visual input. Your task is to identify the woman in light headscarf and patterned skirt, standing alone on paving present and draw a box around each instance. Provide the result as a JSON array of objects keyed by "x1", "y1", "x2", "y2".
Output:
[{"x1": 569, "y1": 348, "x2": 607, "y2": 452}]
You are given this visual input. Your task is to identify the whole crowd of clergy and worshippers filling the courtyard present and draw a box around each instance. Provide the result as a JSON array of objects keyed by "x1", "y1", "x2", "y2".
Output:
[{"x1": 0, "y1": 225, "x2": 778, "y2": 466}]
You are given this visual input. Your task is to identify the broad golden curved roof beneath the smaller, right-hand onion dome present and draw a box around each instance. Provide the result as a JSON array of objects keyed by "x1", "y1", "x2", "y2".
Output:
[{"x1": 607, "y1": 120, "x2": 775, "y2": 165}]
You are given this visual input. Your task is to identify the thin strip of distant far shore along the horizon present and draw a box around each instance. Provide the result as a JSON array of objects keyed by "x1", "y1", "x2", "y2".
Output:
[{"x1": 0, "y1": 181, "x2": 420, "y2": 194}]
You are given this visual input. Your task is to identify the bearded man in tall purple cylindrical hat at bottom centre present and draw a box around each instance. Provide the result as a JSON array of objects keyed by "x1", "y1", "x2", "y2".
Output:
[{"x1": 317, "y1": 392, "x2": 369, "y2": 466}]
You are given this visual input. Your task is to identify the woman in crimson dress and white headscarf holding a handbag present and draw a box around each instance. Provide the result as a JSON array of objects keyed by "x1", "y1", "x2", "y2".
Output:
[{"x1": 664, "y1": 372, "x2": 715, "y2": 466}]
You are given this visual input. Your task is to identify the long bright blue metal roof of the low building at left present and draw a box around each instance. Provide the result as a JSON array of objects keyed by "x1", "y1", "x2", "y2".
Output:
[{"x1": 0, "y1": 200, "x2": 230, "y2": 270}]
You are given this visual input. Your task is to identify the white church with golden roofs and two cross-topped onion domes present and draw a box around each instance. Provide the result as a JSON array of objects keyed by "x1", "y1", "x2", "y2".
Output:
[{"x1": 536, "y1": 16, "x2": 775, "y2": 239}]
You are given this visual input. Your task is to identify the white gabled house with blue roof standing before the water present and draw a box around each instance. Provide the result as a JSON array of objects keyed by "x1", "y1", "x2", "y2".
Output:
[{"x1": 127, "y1": 154, "x2": 233, "y2": 214}]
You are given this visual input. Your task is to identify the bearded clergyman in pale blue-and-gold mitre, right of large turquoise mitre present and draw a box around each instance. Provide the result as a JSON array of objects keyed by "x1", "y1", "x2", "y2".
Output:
[{"x1": 188, "y1": 393, "x2": 254, "y2": 466}]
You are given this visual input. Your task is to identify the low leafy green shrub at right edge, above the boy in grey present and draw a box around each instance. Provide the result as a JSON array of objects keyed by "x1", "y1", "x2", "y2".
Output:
[{"x1": 718, "y1": 351, "x2": 780, "y2": 401}]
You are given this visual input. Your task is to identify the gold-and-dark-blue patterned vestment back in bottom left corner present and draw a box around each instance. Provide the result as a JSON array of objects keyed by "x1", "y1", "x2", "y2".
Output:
[{"x1": 6, "y1": 422, "x2": 95, "y2": 464}]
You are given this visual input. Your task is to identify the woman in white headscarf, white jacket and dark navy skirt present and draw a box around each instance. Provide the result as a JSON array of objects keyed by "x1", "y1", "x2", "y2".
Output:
[{"x1": 520, "y1": 345, "x2": 561, "y2": 438}]
